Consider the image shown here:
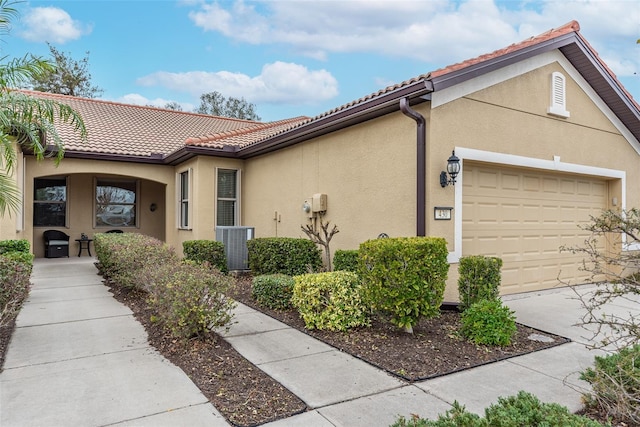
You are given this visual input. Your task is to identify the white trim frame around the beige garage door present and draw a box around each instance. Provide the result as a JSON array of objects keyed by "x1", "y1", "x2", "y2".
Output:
[{"x1": 447, "y1": 147, "x2": 628, "y2": 263}]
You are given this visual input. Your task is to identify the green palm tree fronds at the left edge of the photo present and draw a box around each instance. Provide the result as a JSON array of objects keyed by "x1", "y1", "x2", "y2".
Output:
[{"x1": 0, "y1": 0, "x2": 87, "y2": 215}]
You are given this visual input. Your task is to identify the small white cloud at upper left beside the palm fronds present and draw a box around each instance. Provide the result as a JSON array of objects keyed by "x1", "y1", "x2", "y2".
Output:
[{"x1": 19, "y1": 6, "x2": 92, "y2": 44}]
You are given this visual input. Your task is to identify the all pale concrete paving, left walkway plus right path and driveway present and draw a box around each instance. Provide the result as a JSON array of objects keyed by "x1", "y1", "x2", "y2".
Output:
[{"x1": 0, "y1": 257, "x2": 639, "y2": 427}]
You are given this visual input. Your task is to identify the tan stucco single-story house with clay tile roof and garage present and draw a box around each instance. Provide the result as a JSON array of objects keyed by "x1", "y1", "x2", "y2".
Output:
[{"x1": 0, "y1": 21, "x2": 640, "y2": 299}]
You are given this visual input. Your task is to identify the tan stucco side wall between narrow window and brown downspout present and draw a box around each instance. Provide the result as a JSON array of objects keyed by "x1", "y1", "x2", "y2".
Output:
[{"x1": 243, "y1": 109, "x2": 427, "y2": 249}]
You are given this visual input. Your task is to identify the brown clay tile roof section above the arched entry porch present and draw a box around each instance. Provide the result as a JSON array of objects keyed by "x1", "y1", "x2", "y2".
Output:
[{"x1": 21, "y1": 90, "x2": 265, "y2": 157}]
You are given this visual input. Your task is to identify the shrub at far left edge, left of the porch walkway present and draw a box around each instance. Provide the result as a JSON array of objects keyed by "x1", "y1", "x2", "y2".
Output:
[{"x1": 0, "y1": 251, "x2": 33, "y2": 326}]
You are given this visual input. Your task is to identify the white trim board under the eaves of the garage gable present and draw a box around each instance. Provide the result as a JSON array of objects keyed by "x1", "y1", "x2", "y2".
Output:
[{"x1": 431, "y1": 50, "x2": 640, "y2": 154}]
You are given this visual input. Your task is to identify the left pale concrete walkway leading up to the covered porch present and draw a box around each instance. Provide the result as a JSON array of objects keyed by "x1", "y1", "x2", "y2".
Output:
[{"x1": 0, "y1": 257, "x2": 228, "y2": 427}]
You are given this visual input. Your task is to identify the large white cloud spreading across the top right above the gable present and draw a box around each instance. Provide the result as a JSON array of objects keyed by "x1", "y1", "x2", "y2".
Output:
[{"x1": 189, "y1": 0, "x2": 640, "y2": 77}]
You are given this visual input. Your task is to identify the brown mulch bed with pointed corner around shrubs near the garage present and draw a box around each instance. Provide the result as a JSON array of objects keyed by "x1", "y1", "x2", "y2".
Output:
[{"x1": 232, "y1": 277, "x2": 570, "y2": 382}]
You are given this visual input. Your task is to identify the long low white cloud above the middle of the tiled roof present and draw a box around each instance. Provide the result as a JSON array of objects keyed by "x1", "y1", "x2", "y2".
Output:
[{"x1": 137, "y1": 62, "x2": 338, "y2": 104}]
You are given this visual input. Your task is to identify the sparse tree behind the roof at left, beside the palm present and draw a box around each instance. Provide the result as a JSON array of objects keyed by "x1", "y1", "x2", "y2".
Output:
[{"x1": 29, "y1": 44, "x2": 103, "y2": 98}]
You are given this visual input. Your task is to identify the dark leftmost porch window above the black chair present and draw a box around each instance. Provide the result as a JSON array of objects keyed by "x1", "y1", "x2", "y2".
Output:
[{"x1": 33, "y1": 178, "x2": 67, "y2": 227}]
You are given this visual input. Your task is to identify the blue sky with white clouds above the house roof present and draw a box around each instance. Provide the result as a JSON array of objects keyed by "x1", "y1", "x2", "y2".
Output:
[{"x1": 0, "y1": 0, "x2": 640, "y2": 121}]
